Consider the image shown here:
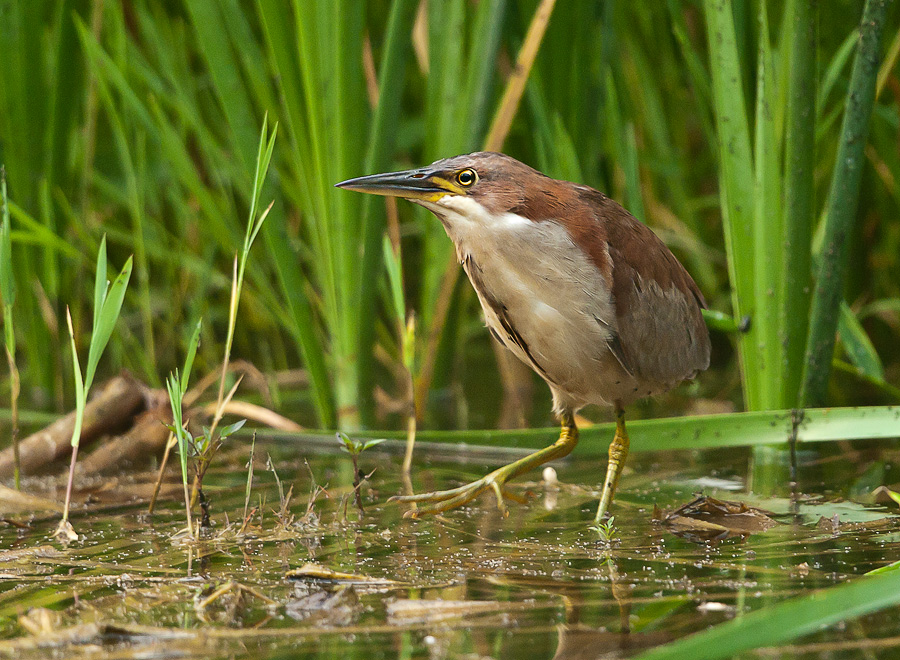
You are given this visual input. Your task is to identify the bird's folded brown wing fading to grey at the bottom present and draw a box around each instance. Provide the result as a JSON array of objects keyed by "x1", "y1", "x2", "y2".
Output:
[{"x1": 591, "y1": 191, "x2": 710, "y2": 383}]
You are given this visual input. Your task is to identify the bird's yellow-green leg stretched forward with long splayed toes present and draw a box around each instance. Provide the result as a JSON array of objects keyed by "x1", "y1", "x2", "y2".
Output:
[{"x1": 390, "y1": 411, "x2": 578, "y2": 518}]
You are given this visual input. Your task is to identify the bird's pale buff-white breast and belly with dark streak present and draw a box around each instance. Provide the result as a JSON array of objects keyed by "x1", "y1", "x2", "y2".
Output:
[{"x1": 455, "y1": 213, "x2": 659, "y2": 412}]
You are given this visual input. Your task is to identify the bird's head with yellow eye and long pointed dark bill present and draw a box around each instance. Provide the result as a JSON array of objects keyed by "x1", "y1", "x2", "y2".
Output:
[{"x1": 336, "y1": 151, "x2": 551, "y2": 216}]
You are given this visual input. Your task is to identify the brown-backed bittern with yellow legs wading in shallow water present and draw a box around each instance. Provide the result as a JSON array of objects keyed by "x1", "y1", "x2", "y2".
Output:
[{"x1": 335, "y1": 151, "x2": 710, "y2": 525}]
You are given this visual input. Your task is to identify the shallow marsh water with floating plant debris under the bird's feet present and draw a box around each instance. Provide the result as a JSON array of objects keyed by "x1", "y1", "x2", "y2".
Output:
[{"x1": 0, "y1": 439, "x2": 900, "y2": 659}]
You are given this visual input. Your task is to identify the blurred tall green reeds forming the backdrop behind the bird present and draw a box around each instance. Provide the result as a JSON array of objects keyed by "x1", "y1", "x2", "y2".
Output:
[{"x1": 0, "y1": 0, "x2": 900, "y2": 428}]
